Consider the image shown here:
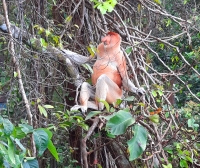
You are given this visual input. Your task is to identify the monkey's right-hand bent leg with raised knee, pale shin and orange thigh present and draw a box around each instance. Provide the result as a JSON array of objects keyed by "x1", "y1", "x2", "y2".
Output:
[{"x1": 95, "y1": 74, "x2": 122, "y2": 110}]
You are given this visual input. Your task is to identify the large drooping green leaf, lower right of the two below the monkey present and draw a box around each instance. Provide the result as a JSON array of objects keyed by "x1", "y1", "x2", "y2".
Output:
[{"x1": 127, "y1": 124, "x2": 147, "y2": 161}]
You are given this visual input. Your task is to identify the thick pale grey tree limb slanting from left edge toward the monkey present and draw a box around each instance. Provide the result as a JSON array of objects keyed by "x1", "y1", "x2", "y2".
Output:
[{"x1": 0, "y1": 14, "x2": 90, "y2": 87}]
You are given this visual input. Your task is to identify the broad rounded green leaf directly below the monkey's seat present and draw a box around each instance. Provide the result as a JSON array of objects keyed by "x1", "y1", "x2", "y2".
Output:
[{"x1": 106, "y1": 110, "x2": 135, "y2": 135}]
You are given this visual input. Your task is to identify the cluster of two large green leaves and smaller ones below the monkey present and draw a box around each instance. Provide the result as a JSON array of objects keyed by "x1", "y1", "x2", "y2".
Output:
[{"x1": 86, "y1": 101, "x2": 147, "y2": 161}]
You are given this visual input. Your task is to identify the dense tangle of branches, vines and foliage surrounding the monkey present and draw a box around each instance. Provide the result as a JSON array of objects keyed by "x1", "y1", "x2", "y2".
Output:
[{"x1": 0, "y1": 0, "x2": 200, "y2": 168}]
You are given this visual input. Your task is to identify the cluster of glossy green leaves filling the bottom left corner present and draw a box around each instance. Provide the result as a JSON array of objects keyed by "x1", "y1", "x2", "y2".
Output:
[{"x1": 0, "y1": 116, "x2": 59, "y2": 168}]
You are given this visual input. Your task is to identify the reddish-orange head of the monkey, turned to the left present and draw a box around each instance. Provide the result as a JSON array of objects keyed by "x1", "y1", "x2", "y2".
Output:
[{"x1": 101, "y1": 32, "x2": 121, "y2": 48}]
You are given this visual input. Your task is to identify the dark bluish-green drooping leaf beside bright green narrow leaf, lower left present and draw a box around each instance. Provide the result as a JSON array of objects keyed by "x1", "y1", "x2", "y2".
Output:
[{"x1": 33, "y1": 129, "x2": 49, "y2": 156}]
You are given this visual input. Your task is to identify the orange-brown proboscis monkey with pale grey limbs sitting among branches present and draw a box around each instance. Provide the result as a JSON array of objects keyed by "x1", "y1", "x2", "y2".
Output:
[{"x1": 71, "y1": 32, "x2": 145, "y2": 113}]
